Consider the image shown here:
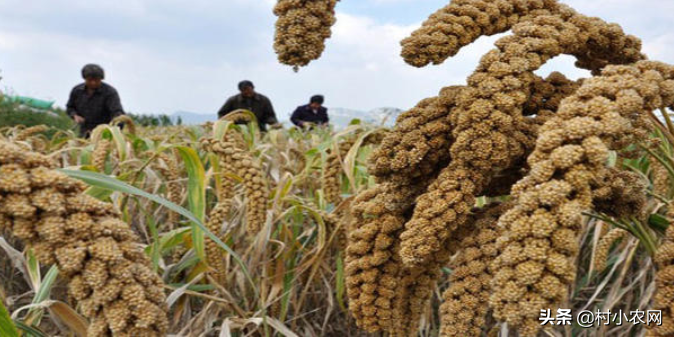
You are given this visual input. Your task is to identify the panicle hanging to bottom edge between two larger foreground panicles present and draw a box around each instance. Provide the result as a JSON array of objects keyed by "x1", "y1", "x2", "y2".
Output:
[{"x1": 440, "y1": 204, "x2": 512, "y2": 336}]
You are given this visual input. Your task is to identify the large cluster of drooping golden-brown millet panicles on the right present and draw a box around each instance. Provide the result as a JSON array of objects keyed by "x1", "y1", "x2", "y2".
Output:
[{"x1": 272, "y1": 0, "x2": 674, "y2": 336}]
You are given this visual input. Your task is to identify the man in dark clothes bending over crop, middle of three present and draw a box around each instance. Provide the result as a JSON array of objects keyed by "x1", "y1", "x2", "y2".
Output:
[{"x1": 218, "y1": 81, "x2": 280, "y2": 131}]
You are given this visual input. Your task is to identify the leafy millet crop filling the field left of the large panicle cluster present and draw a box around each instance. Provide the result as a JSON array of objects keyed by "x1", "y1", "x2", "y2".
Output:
[{"x1": 0, "y1": 117, "x2": 382, "y2": 336}]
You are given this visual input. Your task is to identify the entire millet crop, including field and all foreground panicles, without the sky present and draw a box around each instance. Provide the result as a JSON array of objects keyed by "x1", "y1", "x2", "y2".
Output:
[{"x1": 0, "y1": 0, "x2": 674, "y2": 336}]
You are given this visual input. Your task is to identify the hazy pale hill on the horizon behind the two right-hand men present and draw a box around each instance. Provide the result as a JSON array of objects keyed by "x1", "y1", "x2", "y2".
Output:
[{"x1": 170, "y1": 107, "x2": 403, "y2": 129}]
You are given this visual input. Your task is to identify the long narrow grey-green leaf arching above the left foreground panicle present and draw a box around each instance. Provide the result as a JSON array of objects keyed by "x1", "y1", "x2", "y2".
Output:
[{"x1": 58, "y1": 169, "x2": 259, "y2": 296}]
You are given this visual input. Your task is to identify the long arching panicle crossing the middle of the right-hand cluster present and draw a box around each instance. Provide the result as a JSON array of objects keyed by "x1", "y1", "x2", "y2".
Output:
[{"x1": 401, "y1": 5, "x2": 643, "y2": 265}]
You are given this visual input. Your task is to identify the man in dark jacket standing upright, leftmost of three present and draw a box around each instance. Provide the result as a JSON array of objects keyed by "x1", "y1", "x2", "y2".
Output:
[{"x1": 66, "y1": 64, "x2": 124, "y2": 137}]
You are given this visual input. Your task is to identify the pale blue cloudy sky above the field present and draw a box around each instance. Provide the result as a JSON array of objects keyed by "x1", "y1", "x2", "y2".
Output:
[{"x1": 0, "y1": 0, "x2": 674, "y2": 120}]
